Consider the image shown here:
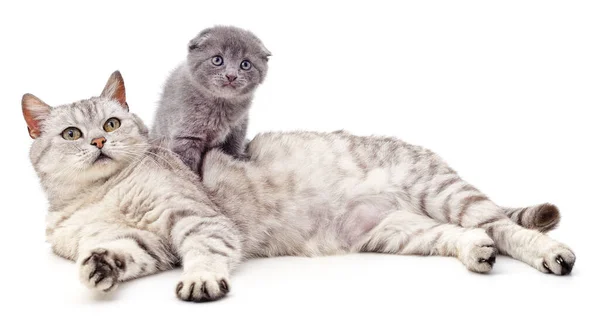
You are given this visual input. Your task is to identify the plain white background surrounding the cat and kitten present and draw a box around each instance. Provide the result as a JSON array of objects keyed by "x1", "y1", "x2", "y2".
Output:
[{"x1": 0, "y1": 0, "x2": 600, "y2": 320}]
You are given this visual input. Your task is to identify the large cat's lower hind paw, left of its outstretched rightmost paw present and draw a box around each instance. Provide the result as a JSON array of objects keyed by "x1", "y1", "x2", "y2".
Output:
[{"x1": 458, "y1": 229, "x2": 498, "y2": 273}]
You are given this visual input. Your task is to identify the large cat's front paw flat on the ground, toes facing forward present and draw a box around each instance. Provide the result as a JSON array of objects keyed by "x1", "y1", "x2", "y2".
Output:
[{"x1": 175, "y1": 272, "x2": 229, "y2": 302}]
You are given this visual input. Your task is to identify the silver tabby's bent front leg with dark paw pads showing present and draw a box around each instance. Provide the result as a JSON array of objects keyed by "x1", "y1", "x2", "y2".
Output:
[{"x1": 77, "y1": 223, "x2": 176, "y2": 292}]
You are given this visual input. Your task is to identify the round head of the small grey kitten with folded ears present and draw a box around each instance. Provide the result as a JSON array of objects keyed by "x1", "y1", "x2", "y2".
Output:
[{"x1": 187, "y1": 26, "x2": 271, "y2": 98}]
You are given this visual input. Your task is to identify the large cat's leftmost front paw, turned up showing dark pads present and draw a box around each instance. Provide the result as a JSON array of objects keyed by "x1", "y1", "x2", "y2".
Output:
[{"x1": 79, "y1": 248, "x2": 125, "y2": 292}]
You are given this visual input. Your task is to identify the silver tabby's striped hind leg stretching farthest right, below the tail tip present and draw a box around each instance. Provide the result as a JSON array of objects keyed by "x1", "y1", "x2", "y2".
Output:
[{"x1": 423, "y1": 177, "x2": 575, "y2": 275}]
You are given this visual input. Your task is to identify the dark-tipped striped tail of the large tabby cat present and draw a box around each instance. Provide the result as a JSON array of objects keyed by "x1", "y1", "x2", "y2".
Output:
[{"x1": 504, "y1": 203, "x2": 560, "y2": 232}]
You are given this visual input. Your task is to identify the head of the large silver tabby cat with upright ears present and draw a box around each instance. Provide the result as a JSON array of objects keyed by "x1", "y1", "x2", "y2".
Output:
[{"x1": 21, "y1": 71, "x2": 148, "y2": 183}]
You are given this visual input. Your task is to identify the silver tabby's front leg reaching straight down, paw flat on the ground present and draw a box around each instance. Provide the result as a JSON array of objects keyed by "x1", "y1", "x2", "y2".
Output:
[{"x1": 170, "y1": 214, "x2": 242, "y2": 302}]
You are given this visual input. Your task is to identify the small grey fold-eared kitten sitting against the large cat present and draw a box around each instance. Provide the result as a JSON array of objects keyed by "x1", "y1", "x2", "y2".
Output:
[{"x1": 151, "y1": 26, "x2": 271, "y2": 172}]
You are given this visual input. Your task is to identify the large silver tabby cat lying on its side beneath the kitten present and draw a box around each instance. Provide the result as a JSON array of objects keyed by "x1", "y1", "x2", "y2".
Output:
[{"x1": 22, "y1": 72, "x2": 575, "y2": 302}]
